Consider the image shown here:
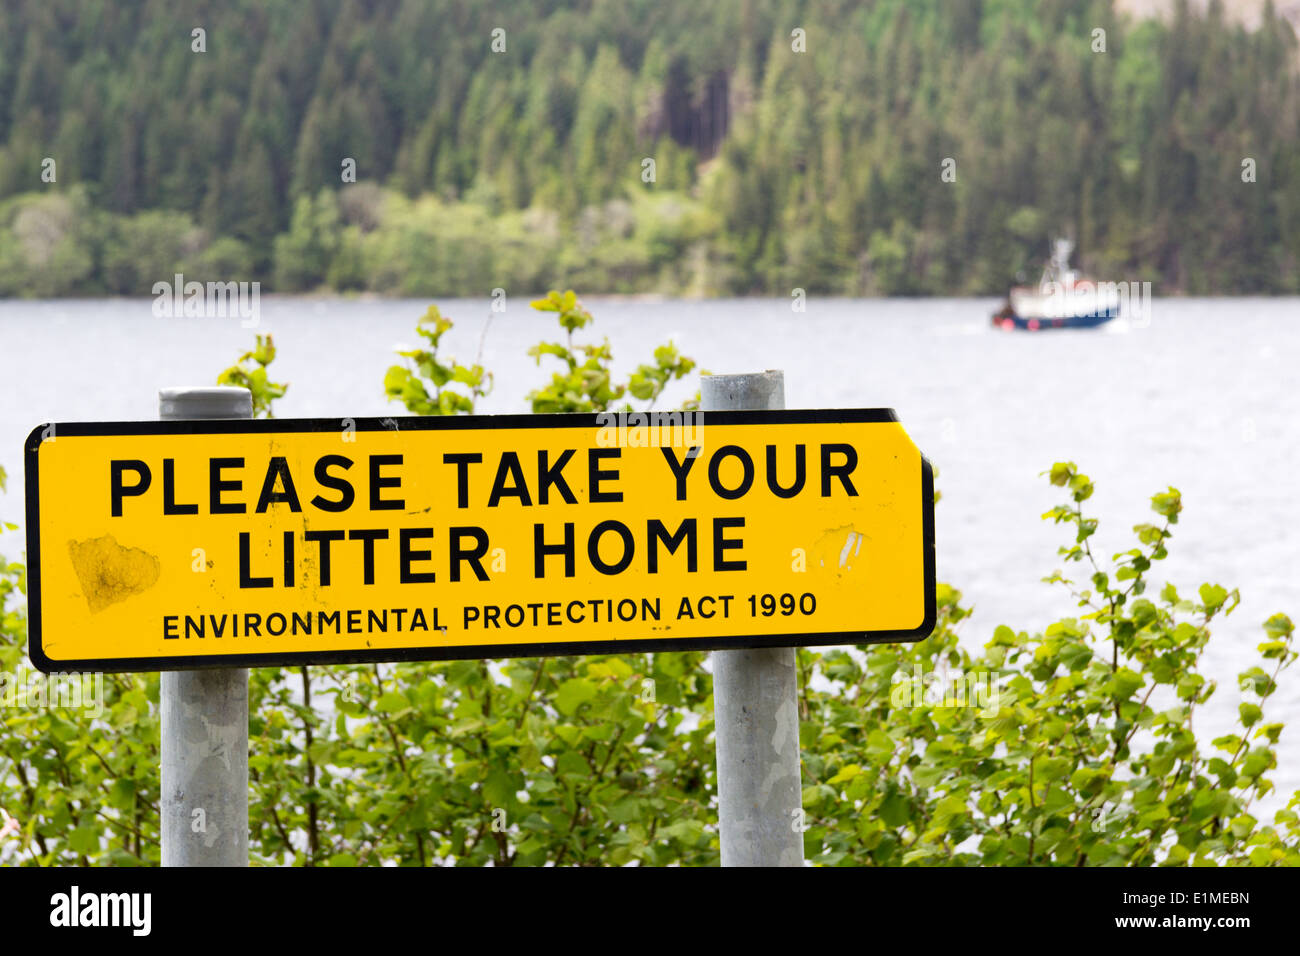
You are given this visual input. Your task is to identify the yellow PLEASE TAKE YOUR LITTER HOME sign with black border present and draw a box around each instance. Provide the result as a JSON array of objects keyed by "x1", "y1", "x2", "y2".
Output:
[{"x1": 26, "y1": 410, "x2": 935, "y2": 671}]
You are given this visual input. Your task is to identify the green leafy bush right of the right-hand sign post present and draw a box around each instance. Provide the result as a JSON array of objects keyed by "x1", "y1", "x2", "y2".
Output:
[{"x1": 800, "y1": 463, "x2": 1300, "y2": 866}]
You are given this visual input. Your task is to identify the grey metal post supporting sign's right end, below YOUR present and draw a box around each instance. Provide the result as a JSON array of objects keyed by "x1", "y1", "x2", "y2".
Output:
[{"x1": 699, "y1": 371, "x2": 803, "y2": 866}]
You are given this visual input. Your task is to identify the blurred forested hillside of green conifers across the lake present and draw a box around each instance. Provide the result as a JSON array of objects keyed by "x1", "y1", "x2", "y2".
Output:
[{"x1": 0, "y1": 0, "x2": 1300, "y2": 295}]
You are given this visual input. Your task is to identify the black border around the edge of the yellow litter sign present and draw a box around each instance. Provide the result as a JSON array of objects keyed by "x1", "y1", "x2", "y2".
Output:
[{"x1": 23, "y1": 408, "x2": 937, "y2": 674}]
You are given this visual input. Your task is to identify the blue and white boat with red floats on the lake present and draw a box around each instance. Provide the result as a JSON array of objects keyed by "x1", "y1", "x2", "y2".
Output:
[{"x1": 993, "y1": 239, "x2": 1119, "y2": 332}]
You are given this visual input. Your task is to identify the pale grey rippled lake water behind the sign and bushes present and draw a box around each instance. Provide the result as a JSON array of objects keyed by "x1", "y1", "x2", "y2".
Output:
[{"x1": 0, "y1": 297, "x2": 1300, "y2": 805}]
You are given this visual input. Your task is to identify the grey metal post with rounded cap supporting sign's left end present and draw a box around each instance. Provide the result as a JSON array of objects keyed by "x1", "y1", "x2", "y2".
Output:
[{"x1": 159, "y1": 386, "x2": 252, "y2": 866}]
